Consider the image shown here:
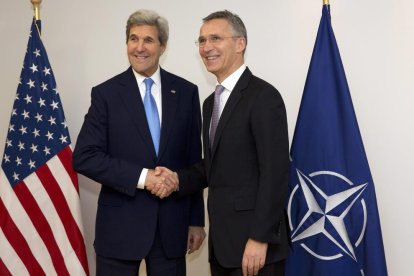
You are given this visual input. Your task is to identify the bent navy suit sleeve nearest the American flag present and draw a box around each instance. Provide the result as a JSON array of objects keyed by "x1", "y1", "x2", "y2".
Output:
[{"x1": 73, "y1": 87, "x2": 142, "y2": 196}]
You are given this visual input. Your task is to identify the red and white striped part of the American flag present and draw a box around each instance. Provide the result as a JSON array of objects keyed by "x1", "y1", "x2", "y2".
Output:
[{"x1": 0, "y1": 147, "x2": 89, "y2": 276}]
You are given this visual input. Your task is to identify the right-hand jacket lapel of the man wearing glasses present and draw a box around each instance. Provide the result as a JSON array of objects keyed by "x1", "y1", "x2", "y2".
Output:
[{"x1": 209, "y1": 68, "x2": 252, "y2": 158}]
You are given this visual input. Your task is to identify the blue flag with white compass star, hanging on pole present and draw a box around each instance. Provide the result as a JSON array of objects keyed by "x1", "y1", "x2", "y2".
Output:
[{"x1": 286, "y1": 5, "x2": 387, "y2": 276}]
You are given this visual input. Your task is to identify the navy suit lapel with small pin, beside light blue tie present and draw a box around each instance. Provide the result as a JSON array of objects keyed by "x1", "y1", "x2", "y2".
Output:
[{"x1": 158, "y1": 68, "x2": 181, "y2": 159}]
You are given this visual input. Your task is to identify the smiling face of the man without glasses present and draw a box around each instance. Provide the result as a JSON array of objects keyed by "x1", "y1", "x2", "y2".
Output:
[{"x1": 127, "y1": 25, "x2": 165, "y2": 77}]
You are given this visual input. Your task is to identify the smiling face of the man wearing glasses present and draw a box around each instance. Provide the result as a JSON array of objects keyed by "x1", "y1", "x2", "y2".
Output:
[{"x1": 198, "y1": 19, "x2": 246, "y2": 82}]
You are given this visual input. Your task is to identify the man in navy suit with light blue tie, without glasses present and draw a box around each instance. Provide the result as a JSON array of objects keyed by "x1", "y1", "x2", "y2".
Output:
[{"x1": 73, "y1": 10, "x2": 205, "y2": 276}]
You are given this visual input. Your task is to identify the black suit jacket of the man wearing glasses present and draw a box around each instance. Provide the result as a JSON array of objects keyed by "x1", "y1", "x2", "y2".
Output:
[{"x1": 179, "y1": 69, "x2": 289, "y2": 267}]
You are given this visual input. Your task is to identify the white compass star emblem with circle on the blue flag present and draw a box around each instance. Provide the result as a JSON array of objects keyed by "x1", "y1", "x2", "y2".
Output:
[{"x1": 288, "y1": 169, "x2": 368, "y2": 262}]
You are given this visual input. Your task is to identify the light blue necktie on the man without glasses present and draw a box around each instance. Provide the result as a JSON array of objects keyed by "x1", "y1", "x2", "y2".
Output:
[{"x1": 144, "y1": 78, "x2": 161, "y2": 155}]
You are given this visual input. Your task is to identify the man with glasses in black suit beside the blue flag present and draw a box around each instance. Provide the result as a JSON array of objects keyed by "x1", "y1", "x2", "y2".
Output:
[{"x1": 152, "y1": 11, "x2": 289, "y2": 276}]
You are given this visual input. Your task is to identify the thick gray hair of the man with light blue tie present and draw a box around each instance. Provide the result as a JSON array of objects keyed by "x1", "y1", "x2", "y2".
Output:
[{"x1": 126, "y1": 9, "x2": 169, "y2": 46}]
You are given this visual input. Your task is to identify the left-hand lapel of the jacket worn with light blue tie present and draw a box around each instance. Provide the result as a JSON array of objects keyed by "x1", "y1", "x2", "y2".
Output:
[{"x1": 119, "y1": 67, "x2": 156, "y2": 157}]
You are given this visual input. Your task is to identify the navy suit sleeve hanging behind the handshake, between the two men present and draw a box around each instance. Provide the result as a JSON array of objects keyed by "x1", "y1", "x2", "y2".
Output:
[{"x1": 188, "y1": 87, "x2": 204, "y2": 226}]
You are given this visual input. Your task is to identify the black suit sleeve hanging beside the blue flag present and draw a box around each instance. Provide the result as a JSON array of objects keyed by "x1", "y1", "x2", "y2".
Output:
[{"x1": 250, "y1": 87, "x2": 289, "y2": 243}]
